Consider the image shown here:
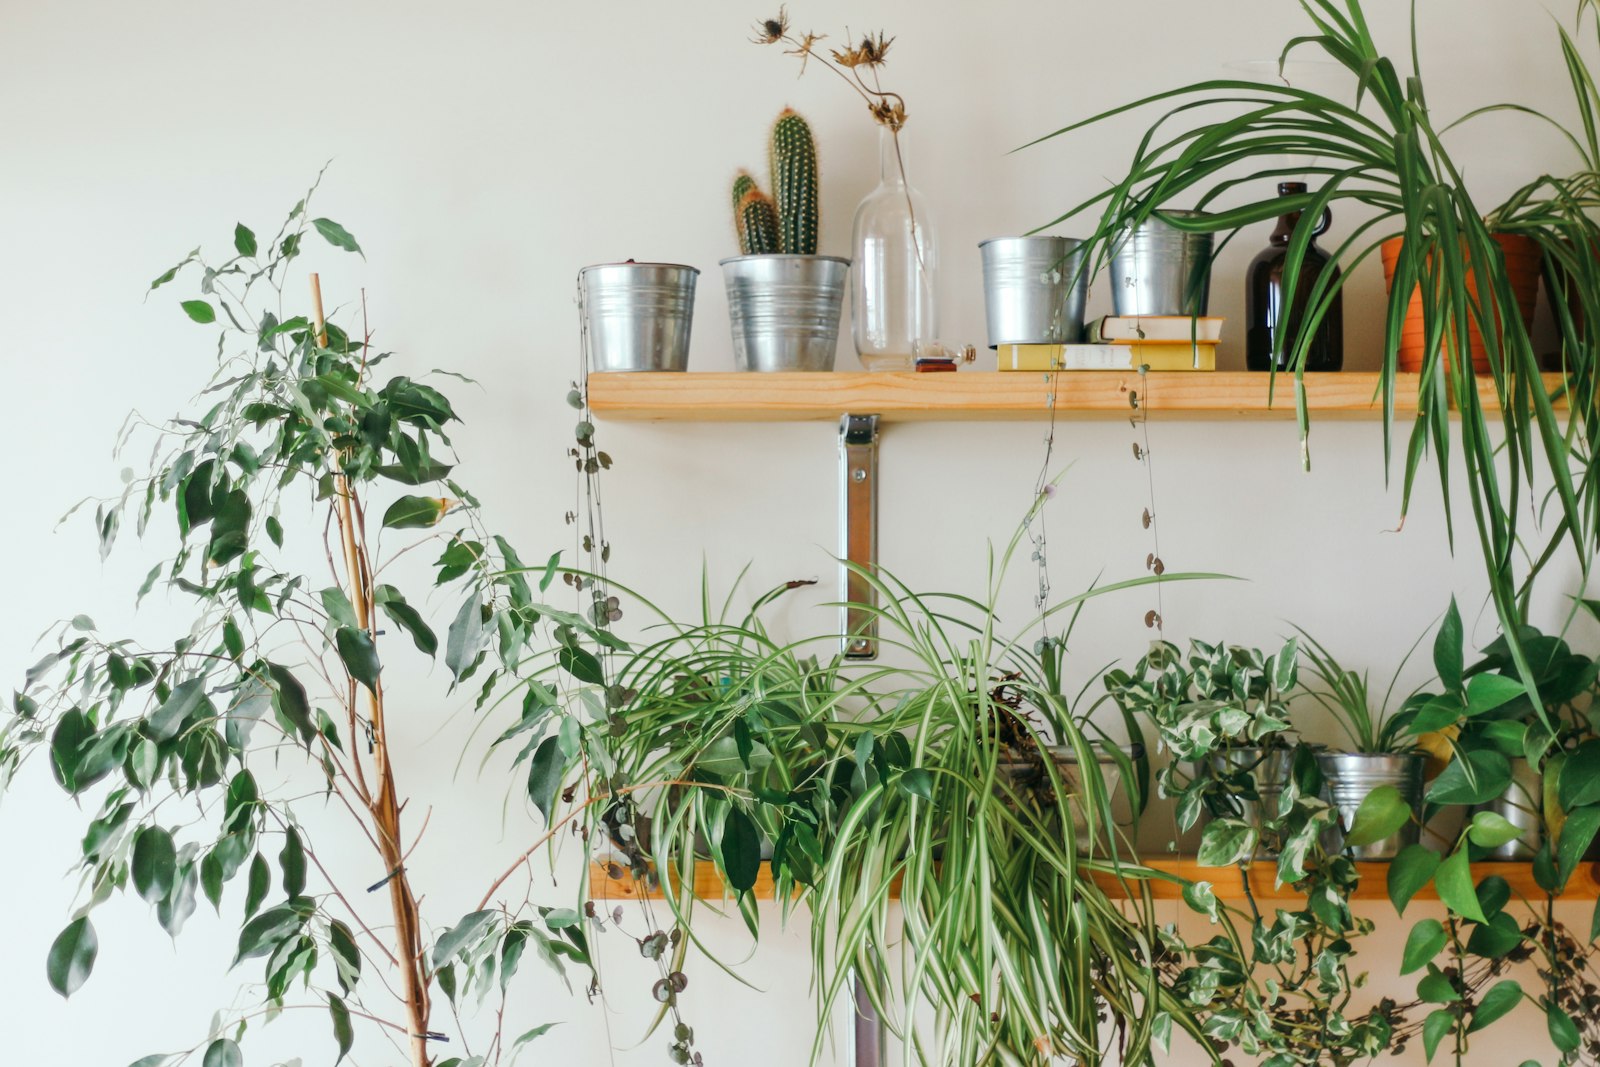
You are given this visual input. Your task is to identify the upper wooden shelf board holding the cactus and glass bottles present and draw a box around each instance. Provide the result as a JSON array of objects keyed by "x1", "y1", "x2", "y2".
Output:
[{"x1": 589, "y1": 371, "x2": 1560, "y2": 422}]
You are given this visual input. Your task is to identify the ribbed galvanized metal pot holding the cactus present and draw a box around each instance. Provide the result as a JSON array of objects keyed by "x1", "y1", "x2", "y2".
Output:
[{"x1": 722, "y1": 256, "x2": 850, "y2": 371}]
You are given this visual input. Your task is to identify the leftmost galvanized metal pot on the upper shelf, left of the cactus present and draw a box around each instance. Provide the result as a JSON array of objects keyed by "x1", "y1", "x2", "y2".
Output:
[{"x1": 578, "y1": 259, "x2": 699, "y2": 371}]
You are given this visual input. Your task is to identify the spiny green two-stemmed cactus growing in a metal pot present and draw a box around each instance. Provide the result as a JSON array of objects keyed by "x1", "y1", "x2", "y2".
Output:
[{"x1": 733, "y1": 107, "x2": 819, "y2": 256}]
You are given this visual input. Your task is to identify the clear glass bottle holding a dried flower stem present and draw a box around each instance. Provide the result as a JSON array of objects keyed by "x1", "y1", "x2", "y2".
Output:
[{"x1": 850, "y1": 126, "x2": 942, "y2": 371}]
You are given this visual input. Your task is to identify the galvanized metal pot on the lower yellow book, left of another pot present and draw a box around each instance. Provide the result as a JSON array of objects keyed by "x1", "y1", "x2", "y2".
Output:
[{"x1": 978, "y1": 237, "x2": 1090, "y2": 349}]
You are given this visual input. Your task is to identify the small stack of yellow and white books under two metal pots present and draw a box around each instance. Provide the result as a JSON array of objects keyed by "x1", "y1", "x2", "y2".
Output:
[{"x1": 995, "y1": 315, "x2": 1222, "y2": 371}]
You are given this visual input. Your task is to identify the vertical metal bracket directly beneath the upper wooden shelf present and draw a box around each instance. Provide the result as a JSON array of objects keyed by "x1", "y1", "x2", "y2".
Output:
[{"x1": 838, "y1": 414, "x2": 878, "y2": 659}]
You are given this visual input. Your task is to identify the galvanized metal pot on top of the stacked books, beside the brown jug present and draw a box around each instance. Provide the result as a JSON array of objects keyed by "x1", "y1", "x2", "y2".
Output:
[{"x1": 1110, "y1": 211, "x2": 1211, "y2": 315}]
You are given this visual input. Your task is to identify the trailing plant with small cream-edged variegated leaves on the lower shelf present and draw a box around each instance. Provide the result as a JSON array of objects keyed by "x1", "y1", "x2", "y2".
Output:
[{"x1": 1106, "y1": 640, "x2": 1400, "y2": 1067}]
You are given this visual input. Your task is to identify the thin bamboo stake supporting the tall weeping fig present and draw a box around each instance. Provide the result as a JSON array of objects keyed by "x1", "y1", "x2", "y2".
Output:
[{"x1": 310, "y1": 274, "x2": 432, "y2": 1067}]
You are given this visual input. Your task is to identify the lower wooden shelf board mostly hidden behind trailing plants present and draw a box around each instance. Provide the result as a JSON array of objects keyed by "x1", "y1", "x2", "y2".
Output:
[{"x1": 589, "y1": 856, "x2": 1600, "y2": 904}]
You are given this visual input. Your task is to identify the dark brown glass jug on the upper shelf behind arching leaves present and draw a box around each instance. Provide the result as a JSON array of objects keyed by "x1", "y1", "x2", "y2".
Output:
[{"x1": 1245, "y1": 181, "x2": 1344, "y2": 371}]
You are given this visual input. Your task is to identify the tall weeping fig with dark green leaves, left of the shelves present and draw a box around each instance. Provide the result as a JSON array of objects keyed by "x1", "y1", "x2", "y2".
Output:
[{"x1": 0, "y1": 195, "x2": 619, "y2": 1067}]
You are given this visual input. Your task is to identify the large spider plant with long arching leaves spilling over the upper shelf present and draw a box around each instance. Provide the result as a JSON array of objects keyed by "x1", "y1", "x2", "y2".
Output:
[{"x1": 1042, "y1": 0, "x2": 1600, "y2": 735}]
